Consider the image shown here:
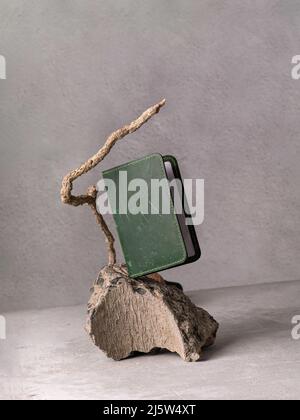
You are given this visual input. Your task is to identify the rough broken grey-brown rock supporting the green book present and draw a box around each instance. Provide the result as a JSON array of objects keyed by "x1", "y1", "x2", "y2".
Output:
[{"x1": 87, "y1": 266, "x2": 218, "y2": 361}]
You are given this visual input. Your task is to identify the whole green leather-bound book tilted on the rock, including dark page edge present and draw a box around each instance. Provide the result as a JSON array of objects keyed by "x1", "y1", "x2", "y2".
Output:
[{"x1": 103, "y1": 154, "x2": 200, "y2": 277}]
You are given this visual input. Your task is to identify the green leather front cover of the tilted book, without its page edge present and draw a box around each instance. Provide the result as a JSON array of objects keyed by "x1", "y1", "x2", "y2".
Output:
[{"x1": 103, "y1": 154, "x2": 187, "y2": 277}]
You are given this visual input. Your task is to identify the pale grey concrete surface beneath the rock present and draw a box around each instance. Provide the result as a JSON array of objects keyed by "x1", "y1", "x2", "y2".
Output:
[{"x1": 0, "y1": 281, "x2": 300, "y2": 399}]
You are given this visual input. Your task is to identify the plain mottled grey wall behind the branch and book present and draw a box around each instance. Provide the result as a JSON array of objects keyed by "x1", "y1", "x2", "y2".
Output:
[{"x1": 0, "y1": 0, "x2": 300, "y2": 312}]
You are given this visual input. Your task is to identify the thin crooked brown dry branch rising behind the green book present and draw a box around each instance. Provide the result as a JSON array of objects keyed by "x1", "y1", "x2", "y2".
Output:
[{"x1": 60, "y1": 99, "x2": 166, "y2": 265}]
